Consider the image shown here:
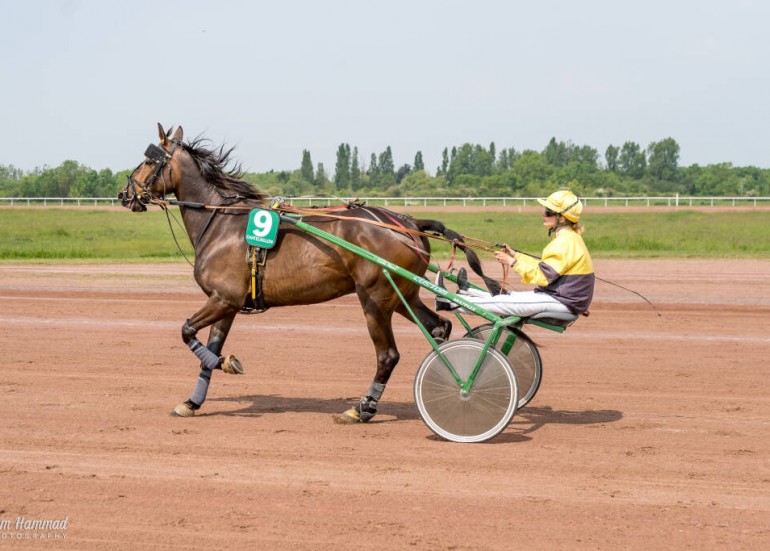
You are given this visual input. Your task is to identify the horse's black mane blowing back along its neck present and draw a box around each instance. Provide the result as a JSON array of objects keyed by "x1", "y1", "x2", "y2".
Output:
[{"x1": 182, "y1": 137, "x2": 269, "y2": 201}]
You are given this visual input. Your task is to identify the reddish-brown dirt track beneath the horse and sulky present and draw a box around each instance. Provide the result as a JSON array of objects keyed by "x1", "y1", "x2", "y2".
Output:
[{"x1": 0, "y1": 261, "x2": 770, "y2": 550}]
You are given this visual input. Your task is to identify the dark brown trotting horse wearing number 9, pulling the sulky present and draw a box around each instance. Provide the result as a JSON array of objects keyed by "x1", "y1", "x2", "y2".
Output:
[{"x1": 118, "y1": 123, "x2": 492, "y2": 423}]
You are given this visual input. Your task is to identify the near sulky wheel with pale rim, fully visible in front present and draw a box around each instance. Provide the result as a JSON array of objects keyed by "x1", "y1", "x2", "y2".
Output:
[{"x1": 414, "y1": 339, "x2": 518, "y2": 442}]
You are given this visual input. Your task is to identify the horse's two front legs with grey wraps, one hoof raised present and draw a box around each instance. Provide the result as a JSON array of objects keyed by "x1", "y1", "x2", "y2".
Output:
[{"x1": 174, "y1": 299, "x2": 238, "y2": 417}]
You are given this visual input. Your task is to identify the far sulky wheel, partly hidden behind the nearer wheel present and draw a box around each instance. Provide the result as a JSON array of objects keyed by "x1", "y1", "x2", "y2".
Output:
[{"x1": 465, "y1": 323, "x2": 543, "y2": 409}]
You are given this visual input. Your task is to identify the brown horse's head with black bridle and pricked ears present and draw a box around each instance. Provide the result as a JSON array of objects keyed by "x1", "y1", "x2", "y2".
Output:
[{"x1": 118, "y1": 123, "x2": 183, "y2": 212}]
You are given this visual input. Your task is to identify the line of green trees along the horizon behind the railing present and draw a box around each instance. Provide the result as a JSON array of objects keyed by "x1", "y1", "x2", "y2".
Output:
[{"x1": 0, "y1": 138, "x2": 770, "y2": 197}]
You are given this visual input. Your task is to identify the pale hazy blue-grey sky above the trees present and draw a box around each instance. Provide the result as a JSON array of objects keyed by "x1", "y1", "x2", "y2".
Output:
[{"x1": 0, "y1": 0, "x2": 770, "y2": 176}]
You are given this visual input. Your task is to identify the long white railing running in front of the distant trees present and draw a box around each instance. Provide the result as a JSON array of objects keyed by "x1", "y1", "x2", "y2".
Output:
[{"x1": 0, "y1": 196, "x2": 770, "y2": 207}]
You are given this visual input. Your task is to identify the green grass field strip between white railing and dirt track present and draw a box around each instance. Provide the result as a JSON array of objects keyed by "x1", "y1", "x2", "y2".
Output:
[{"x1": 0, "y1": 207, "x2": 770, "y2": 262}]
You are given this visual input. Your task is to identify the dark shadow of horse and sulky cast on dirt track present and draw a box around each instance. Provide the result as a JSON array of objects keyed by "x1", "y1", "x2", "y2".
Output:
[{"x1": 200, "y1": 394, "x2": 623, "y2": 444}]
